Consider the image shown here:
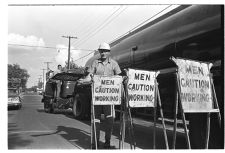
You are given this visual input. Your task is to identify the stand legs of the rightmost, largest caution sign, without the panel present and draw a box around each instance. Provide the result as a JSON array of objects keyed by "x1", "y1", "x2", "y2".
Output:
[{"x1": 172, "y1": 72, "x2": 221, "y2": 149}]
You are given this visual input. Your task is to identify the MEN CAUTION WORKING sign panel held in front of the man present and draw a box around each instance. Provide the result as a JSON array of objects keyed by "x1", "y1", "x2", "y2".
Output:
[{"x1": 92, "y1": 75, "x2": 122, "y2": 105}]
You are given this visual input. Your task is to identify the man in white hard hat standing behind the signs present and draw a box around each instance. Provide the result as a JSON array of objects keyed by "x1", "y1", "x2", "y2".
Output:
[{"x1": 82, "y1": 43, "x2": 121, "y2": 149}]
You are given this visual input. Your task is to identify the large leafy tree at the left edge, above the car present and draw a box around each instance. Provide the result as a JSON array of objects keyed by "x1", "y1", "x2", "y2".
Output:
[{"x1": 8, "y1": 64, "x2": 30, "y2": 89}]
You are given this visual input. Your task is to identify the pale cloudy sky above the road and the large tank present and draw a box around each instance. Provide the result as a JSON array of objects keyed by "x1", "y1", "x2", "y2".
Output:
[{"x1": 8, "y1": 4, "x2": 178, "y2": 87}]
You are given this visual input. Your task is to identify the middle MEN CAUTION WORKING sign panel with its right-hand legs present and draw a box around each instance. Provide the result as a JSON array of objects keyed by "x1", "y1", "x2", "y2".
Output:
[{"x1": 126, "y1": 69, "x2": 169, "y2": 149}]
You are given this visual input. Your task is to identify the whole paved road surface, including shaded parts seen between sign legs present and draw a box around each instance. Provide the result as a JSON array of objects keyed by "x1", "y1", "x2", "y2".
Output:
[{"x1": 8, "y1": 95, "x2": 186, "y2": 149}]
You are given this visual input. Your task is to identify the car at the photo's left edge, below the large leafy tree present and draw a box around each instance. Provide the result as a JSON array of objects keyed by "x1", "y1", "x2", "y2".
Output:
[{"x1": 8, "y1": 88, "x2": 22, "y2": 109}]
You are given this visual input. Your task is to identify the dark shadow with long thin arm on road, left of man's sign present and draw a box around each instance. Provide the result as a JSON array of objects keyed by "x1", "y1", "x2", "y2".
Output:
[{"x1": 31, "y1": 126, "x2": 91, "y2": 149}]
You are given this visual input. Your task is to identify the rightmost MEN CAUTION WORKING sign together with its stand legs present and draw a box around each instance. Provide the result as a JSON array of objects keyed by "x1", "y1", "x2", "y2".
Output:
[{"x1": 171, "y1": 57, "x2": 221, "y2": 149}]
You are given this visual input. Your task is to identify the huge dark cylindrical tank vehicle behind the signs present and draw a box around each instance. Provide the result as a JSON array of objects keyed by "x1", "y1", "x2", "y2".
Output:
[{"x1": 80, "y1": 5, "x2": 224, "y2": 149}]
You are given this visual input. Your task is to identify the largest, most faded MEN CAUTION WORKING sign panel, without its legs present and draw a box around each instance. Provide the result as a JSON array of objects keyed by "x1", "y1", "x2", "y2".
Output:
[{"x1": 172, "y1": 58, "x2": 213, "y2": 112}]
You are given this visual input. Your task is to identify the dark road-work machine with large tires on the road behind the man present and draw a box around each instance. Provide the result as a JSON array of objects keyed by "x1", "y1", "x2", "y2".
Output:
[{"x1": 42, "y1": 68, "x2": 90, "y2": 119}]
